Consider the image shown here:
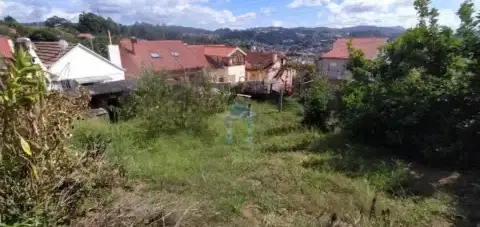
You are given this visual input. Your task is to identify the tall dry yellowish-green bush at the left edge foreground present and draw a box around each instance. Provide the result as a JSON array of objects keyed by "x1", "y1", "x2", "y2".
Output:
[{"x1": 0, "y1": 48, "x2": 118, "y2": 226}]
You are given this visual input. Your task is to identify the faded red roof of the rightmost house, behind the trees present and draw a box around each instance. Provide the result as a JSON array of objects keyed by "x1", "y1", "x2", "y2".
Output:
[{"x1": 322, "y1": 37, "x2": 388, "y2": 60}]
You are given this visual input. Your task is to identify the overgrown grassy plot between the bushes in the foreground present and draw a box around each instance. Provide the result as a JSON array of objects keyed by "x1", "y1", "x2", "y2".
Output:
[{"x1": 72, "y1": 103, "x2": 453, "y2": 226}]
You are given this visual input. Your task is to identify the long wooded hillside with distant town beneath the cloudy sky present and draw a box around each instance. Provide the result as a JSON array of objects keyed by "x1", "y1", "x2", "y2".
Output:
[{"x1": 9, "y1": 13, "x2": 405, "y2": 61}]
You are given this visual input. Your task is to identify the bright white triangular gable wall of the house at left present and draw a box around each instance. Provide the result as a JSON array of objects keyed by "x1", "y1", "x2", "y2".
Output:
[{"x1": 48, "y1": 44, "x2": 125, "y2": 84}]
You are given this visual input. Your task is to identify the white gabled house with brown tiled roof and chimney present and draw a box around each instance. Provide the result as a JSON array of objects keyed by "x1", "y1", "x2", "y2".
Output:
[{"x1": 32, "y1": 40, "x2": 125, "y2": 90}]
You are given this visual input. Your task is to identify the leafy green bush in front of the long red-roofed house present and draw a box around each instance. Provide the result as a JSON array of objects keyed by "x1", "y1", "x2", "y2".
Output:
[{"x1": 127, "y1": 70, "x2": 230, "y2": 135}]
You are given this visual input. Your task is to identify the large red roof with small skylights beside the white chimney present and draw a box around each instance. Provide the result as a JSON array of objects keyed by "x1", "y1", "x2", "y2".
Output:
[{"x1": 120, "y1": 40, "x2": 205, "y2": 78}]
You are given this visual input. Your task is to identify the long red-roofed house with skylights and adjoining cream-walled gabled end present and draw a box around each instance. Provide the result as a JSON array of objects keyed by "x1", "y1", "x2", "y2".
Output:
[{"x1": 120, "y1": 38, "x2": 246, "y2": 83}]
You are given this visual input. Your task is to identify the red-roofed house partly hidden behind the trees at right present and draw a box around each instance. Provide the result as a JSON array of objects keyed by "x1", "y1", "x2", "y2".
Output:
[{"x1": 317, "y1": 37, "x2": 388, "y2": 81}]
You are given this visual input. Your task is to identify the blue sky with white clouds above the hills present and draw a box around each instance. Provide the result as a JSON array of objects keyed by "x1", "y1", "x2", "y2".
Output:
[{"x1": 0, "y1": 0, "x2": 472, "y2": 29}]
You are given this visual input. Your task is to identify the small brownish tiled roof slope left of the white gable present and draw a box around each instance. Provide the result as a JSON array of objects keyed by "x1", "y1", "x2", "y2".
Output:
[{"x1": 33, "y1": 42, "x2": 75, "y2": 68}]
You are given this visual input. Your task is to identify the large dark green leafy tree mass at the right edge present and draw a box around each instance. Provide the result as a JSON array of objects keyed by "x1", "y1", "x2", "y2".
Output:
[{"x1": 341, "y1": 0, "x2": 480, "y2": 167}]
